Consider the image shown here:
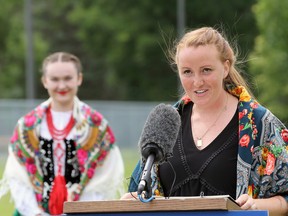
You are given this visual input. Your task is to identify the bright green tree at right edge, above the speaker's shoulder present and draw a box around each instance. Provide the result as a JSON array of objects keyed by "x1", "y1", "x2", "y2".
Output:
[{"x1": 249, "y1": 0, "x2": 288, "y2": 123}]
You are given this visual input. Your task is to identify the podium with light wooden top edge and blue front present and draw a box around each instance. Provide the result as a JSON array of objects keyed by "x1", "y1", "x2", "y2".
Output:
[{"x1": 64, "y1": 196, "x2": 268, "y2": 216}]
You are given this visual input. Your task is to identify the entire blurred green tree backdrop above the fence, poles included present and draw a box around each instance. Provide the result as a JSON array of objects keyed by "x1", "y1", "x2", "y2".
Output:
[{"x1": 0, "y1": 0, "x2": 288, "y2": 122}]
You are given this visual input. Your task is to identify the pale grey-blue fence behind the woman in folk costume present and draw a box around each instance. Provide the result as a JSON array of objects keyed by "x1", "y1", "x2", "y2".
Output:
[{"x1": 0, "y1": 99, "x2": 171, "y2": 149}]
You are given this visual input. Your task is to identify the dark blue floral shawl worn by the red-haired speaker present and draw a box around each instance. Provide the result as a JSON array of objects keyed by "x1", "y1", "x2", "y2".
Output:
[{"x1": 128, "y1": 86, "x2": 288, "y2": 201}]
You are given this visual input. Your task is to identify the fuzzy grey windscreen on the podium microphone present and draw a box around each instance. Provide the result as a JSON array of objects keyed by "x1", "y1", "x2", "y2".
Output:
[{"x1": 139, "y1": 103, "x2": 181, "y2": 163}]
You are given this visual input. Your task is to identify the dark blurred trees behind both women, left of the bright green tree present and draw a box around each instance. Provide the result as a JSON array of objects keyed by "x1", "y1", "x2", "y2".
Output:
[{"x1": 0, "y1": 0, "x2": 257, "y2": 101}]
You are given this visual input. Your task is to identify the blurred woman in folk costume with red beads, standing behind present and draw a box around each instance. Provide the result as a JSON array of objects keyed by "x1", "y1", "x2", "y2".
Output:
[{"x1": 0, "y1": 52, "x2": 124, "y2": 216}]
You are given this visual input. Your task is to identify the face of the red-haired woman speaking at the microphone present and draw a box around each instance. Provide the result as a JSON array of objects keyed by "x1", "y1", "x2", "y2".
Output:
[{"x1": 177, "y1": 45, "x2": 230, "y2": 107}]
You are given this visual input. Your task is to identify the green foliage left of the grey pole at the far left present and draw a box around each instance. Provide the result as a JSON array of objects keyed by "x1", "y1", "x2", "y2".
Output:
[{"x1": 0, "y1": 1, "x2": 24, "y2": 97}]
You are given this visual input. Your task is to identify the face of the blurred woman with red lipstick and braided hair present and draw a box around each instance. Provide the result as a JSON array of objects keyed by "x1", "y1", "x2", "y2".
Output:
[{"x1": 42, "y1": 62, "x2": 82, "y2": 111}]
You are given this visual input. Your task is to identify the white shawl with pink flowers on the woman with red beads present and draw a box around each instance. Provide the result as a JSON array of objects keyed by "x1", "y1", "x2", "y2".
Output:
[{"x1": 9, "y1": 97, "x2": 115, "y2": 211}]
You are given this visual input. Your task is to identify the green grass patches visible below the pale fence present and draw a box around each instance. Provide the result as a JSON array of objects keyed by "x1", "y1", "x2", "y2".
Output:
[{"x1": 0, "y1": 149, "x2": 139, "y2": 216}]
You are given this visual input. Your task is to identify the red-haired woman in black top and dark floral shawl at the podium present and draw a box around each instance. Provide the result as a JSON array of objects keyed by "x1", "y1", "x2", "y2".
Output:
[{"x1": 122, "y1": 27, "x2": 288, "y2": 216}]
